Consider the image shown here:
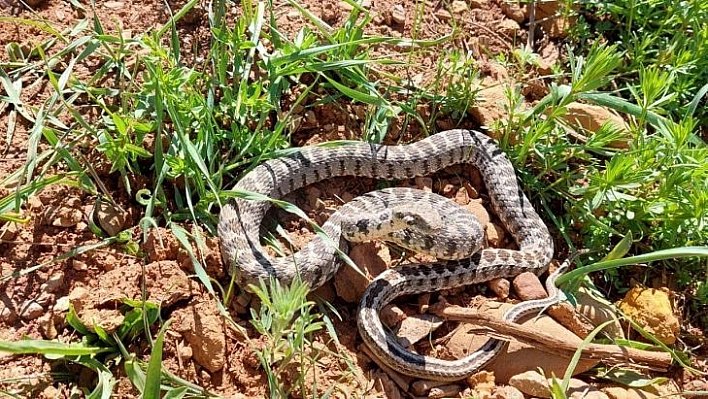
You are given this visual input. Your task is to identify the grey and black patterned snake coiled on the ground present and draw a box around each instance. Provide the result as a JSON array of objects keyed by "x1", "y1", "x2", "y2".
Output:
[{"x1": 217, "y1": 129, "x2": 558, "y2": 381}]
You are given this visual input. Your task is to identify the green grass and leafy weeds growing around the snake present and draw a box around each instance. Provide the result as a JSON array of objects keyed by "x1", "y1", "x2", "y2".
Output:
[{"x1": 0, "y1": 0, "x2": 708, "y2": 397}]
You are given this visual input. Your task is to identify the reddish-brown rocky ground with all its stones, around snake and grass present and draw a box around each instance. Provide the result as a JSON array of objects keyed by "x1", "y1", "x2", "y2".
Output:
[{"x1": 0, "y1": 0, "x2": 706, "y2": 398}]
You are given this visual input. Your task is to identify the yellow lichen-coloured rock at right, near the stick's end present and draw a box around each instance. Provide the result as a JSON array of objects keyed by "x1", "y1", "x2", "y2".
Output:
[{"x1": 617, "y1": 287, "x2": 680, "y2": 345}]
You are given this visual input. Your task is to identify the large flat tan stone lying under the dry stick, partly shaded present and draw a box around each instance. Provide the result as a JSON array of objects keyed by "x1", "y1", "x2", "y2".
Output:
[{"x1": 447, "y1": 301, "x2": 598, "y2": 384}]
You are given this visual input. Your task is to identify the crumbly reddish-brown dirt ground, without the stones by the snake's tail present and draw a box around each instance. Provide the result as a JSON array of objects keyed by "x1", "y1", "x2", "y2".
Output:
[{"x1": 0, "y1": 0, "x2": 708, "y2": 398}]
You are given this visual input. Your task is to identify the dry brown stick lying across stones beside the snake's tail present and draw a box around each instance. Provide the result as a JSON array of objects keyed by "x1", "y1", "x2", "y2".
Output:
[{"x1": 430, "y1": 303, "x2": 671, "y2": 370}]
